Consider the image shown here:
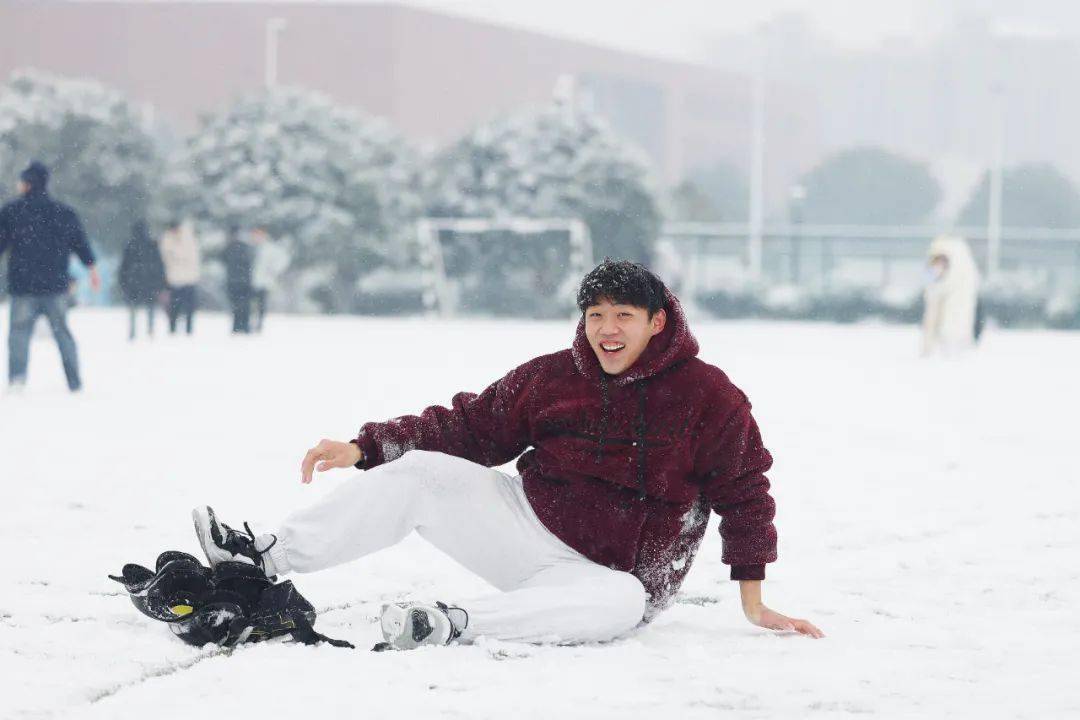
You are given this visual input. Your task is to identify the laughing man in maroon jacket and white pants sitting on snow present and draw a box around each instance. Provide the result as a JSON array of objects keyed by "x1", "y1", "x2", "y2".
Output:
[{"x1": 193, "y1": 260, "x2": 822, "y2": 649}]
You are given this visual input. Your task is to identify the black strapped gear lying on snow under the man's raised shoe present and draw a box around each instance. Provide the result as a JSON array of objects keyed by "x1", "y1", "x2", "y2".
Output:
[{"x1": 109, "y1": 551, "x2": 353, "y2": 648}]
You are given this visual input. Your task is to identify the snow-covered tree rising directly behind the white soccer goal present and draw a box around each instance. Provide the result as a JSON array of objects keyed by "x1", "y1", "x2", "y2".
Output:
[{"x1": 428, "y1": 99, "x2": 661, "y2": 267}]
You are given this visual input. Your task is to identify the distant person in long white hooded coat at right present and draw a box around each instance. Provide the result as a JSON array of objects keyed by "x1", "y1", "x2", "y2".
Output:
[{"x1": 922, "y1": 235, "x2": 978, "y2": 355}]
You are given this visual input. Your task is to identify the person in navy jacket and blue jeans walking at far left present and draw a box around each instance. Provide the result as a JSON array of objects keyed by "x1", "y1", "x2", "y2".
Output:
[{"x1": 0, "y1": 162, "x2": 102, "y2": 392}]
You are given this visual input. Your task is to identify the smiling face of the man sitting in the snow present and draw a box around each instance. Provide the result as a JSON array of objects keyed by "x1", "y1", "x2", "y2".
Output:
[{"x1": 585, "y1": 299, "x2": 667, "y2": 375}]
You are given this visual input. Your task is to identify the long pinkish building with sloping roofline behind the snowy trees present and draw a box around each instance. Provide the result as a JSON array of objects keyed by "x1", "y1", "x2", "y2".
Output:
[{"x1": 0, "y1": 0, "x2": 818, "y2": 207}]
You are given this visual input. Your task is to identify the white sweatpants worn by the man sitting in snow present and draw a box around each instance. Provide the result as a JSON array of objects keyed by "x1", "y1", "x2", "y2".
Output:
[{"x1": 257, "y1": 450, "x2": 646, "y2": 642}]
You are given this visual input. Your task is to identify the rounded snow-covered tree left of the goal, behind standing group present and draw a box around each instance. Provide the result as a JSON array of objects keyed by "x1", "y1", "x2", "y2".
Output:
[{"x1": 174, "y1": 87, "x2": 421, "y2": 312}]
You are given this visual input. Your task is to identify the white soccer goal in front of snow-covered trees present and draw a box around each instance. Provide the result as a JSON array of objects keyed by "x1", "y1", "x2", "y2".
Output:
[{"x1": 417, "y1": 217, "x2": 593, "y2": 317}]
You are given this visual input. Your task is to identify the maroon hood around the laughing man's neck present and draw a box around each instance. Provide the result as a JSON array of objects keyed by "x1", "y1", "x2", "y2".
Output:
[{"x1": 570, "y1": 288, "x2": 699, "y2": 385}]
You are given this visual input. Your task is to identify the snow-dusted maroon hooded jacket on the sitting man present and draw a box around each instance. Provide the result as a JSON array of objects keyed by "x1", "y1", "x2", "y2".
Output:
[{"x1": 354, "y1": 295, "x2": 777, "y2": 616}]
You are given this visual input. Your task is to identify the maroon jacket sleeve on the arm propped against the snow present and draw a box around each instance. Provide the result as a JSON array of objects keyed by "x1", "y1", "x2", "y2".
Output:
[{"x1": 694, "y1": 400, "x2": 777, "y2": 580}]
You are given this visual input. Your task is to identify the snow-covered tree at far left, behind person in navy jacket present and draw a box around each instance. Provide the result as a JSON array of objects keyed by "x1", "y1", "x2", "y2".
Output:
[{"x1": 0, "y1": 70, "x2": 162, "y2": 259}]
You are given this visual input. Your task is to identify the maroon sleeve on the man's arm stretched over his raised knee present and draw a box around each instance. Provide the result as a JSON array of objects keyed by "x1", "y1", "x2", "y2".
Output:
[{"x1": 352, "y1": 364, "x2": 536, "y2": 470}]
